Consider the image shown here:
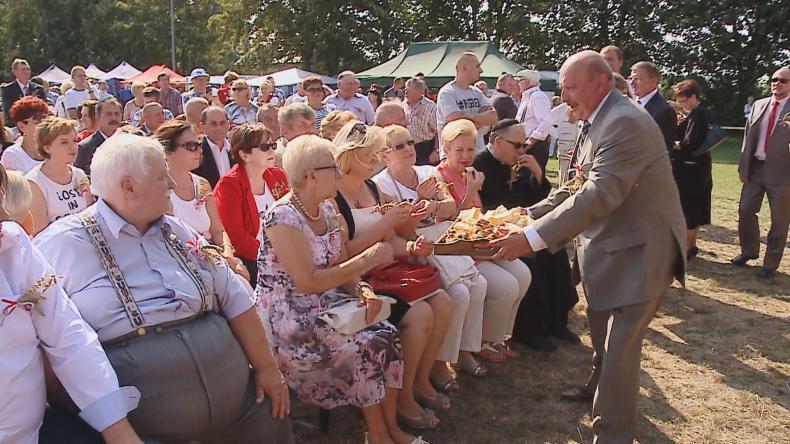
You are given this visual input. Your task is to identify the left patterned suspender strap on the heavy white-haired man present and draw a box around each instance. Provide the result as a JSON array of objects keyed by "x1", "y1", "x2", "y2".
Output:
[{"x1": 79, "y1": 211, "x2": 145, "y2": 328}]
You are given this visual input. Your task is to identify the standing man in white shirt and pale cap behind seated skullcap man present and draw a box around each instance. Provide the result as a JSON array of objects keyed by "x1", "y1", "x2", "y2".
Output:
[{"x1": 516, "y1": 69, "x2": 552, "y2": 170}]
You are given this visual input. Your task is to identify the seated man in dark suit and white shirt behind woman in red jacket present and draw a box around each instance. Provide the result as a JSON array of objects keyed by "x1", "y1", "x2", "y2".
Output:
[{"x1": 192, "y1": 106, "x2": 236, "y2": 188}]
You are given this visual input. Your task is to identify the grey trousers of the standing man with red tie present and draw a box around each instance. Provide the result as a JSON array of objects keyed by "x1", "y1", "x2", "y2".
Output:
[{"x1": 738, "y1": 161, "x2": 790, "y2": 270}]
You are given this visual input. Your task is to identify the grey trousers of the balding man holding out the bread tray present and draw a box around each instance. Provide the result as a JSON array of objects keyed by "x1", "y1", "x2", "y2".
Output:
[{"x1": 585, "y1": 227, "x2": 678, "y2": 444}]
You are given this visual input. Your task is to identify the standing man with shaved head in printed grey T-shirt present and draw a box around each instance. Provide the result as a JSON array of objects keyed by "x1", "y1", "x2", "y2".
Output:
[{"x1": 436, "y1": 52, "x2": 497, "y2": 158}]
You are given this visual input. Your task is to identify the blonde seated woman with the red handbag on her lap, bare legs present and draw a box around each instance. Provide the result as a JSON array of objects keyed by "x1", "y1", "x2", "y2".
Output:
[{"x1": 334, "y1": 120, "x2": 452, "y2": 429}]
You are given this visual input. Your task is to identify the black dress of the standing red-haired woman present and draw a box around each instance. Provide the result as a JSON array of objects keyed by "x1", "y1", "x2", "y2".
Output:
[{"x1": 670, "y1": 104, "x2": 713, "y2": 230}]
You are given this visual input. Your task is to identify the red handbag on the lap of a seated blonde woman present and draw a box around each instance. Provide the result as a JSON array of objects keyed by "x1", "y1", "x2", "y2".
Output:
[{"x1": 365, "y1": 259, "x2": 442, "y2": 304}]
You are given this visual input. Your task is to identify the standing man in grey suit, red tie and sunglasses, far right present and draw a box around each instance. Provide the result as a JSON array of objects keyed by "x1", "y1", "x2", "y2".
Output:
[{"x1": 731, "y1": 67, "x2": 790, "y2": 278}]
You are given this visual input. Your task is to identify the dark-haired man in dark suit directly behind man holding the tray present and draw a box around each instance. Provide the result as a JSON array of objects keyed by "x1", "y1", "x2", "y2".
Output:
[{"x1": 631, "y1": 62, "x2": 678, "y2": 152}]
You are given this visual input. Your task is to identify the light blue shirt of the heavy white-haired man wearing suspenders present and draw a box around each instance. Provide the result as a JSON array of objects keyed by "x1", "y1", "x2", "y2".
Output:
[{"x1": 34, "y1": 199, "x2": 254, "y2": 342}]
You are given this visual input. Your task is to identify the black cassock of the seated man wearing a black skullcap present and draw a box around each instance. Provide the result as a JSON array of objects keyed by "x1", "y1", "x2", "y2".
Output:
[{"x1": 474, "y1": 149, "x2": 579, "y2": 342}]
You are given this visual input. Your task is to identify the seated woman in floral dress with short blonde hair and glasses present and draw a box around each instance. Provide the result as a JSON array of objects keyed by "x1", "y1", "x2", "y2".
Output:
[{"x1": 255, "y1": 136, "x2": 422, "y2": 444}]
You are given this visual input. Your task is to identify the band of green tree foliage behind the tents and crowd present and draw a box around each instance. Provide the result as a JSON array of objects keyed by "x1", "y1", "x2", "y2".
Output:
[{"x1": 0, "y1": 0, "x2": 790, "y2": 123}]
